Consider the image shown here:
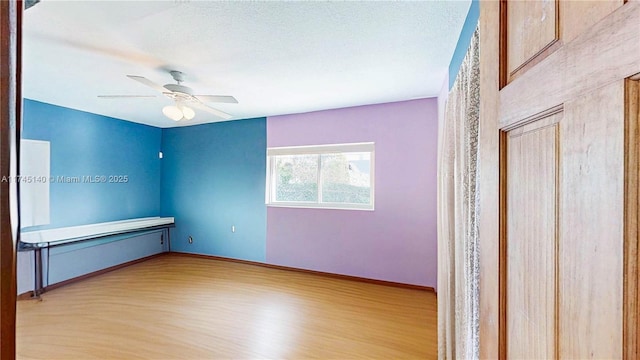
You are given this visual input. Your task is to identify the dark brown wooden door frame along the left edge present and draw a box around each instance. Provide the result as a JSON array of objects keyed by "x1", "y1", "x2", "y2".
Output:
[{"x1": 0, "y1": 1, "x2": 22, "y2": 360}]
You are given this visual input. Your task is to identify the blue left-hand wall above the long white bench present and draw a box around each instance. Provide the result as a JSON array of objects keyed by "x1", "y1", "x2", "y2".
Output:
[{"x1": 22, "y1": 100, "x2": 162, "y2": 229}]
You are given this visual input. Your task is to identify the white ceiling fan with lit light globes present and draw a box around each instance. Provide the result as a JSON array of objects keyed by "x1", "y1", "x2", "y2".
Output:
[{"x1": 98, "y1": 70, "x2": 238, "y2": 121}]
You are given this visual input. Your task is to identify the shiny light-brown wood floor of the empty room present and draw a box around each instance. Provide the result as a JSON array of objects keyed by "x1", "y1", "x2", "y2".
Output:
[{"x1": 16, "y1": 255, "x2": 437, "y2": 359}]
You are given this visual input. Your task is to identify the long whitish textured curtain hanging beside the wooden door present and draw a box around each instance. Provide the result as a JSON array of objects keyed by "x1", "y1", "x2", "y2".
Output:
[{"x1": 438, "y1": 29, "x2": 480, "y2": 359}]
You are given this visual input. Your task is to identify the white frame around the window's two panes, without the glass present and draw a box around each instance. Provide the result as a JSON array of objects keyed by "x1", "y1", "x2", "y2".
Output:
[{"x1": 265, "y1": 142, "x2": 375, "y2": 211}]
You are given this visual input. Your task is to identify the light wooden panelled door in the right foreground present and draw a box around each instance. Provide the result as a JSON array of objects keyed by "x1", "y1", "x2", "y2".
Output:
[{"x1": 479, "y1": 0, "x2": 640, "y2": 359}]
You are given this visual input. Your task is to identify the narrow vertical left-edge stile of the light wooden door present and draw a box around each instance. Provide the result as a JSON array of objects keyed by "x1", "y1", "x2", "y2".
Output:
[{"x1": 478, "y1": 1, "x2": 500, "y2": 359}]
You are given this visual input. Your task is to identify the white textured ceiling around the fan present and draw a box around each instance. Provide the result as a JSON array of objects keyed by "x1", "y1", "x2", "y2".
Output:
[{"x1": 23, "y1": 0, "x2": 470, "y2": 127}]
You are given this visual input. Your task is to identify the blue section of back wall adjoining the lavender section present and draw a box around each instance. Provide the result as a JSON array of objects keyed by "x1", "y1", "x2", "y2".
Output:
[{"x1": 161, "y1": 118, "x2": 267, "y2": 261}]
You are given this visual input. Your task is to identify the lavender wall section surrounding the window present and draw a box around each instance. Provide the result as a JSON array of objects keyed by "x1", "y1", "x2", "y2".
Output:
[{"x1": 266, "y1": 98, "x2": 438, "y2": 287}]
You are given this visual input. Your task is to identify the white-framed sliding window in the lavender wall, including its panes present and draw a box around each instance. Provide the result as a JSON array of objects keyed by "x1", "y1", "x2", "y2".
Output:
[{"x1": 266, "y1": 143, "x2": 374, "y2": 210}]
